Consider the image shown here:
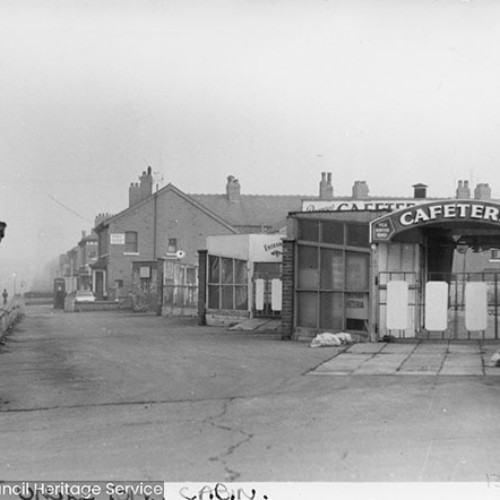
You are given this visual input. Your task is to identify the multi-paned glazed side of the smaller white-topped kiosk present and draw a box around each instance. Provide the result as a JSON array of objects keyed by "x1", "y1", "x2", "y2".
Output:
[{"x1": 208, "y1": 255, "x2": 248, "y2": 311}]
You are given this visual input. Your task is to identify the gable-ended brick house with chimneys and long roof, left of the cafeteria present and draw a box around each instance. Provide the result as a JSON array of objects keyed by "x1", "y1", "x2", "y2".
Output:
[{"x1": 92, "y1": 168, "x2": 301, "y2": 314}]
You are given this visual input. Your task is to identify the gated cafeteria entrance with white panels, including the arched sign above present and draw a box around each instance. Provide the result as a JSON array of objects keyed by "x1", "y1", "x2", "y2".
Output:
[{"x1": 371, "y1": 201, "x2": 500, "y2": 340}]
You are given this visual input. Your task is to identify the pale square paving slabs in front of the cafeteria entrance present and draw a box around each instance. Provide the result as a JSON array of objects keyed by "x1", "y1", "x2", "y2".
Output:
[{"x1": 310, "y1": 341, "x2": 500, "y2": 376}]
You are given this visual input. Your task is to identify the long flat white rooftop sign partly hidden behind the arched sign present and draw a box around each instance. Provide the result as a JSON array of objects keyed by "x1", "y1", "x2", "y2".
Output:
[{"x1": 302, "y1": 199, "x2": 425, "y2": 212}]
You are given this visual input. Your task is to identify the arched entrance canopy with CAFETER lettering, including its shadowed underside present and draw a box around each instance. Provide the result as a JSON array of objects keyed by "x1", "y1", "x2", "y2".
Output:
[{"x1": 370, "y1": 199, "x2": 500, "y2": 246}]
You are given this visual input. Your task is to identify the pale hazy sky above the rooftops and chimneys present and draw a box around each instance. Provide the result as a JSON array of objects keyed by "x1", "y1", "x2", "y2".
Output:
[{"x1": 0, "y1": 0, "x2": 500, "y2": 286}]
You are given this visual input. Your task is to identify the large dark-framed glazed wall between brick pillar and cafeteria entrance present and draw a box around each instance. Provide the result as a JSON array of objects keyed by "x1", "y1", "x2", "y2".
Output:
[{"x1": 295, "y1": 219, "x2": 370, "y2": 332}]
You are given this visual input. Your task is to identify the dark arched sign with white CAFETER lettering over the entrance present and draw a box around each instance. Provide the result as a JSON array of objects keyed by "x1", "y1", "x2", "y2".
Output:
[{"x1": 370, "y1": 200, "x2": 500, "y2": 243}]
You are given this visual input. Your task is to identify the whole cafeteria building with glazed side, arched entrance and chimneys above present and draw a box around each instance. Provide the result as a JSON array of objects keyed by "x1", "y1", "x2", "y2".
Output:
[{"x1": 281, "y1": 174, "x2": 500, "y2": 342}]
